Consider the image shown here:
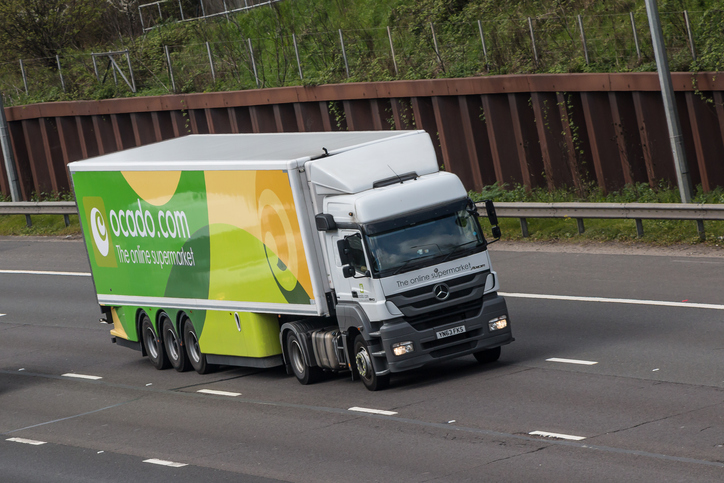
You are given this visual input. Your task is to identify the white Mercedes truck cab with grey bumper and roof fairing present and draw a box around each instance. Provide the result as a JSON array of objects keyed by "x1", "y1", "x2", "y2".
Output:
[{"x1": 280, "y1": 130, "x2": 513, "y2": 390}]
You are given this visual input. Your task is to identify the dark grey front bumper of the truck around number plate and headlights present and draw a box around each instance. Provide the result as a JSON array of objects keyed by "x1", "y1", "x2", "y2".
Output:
[{"x1": 380, "y1": 293, "x2": 514, "y2": 372}]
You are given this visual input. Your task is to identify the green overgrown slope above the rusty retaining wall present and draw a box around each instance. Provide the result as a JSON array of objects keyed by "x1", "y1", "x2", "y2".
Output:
[{"x1": 0, "y1": 0, "x2": 724, "y2": 105}]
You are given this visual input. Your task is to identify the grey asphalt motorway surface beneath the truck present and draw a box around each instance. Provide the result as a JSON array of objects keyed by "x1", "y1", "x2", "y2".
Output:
[{"x1": 0, "y1": 239, "x2": 724, "y2": 482}]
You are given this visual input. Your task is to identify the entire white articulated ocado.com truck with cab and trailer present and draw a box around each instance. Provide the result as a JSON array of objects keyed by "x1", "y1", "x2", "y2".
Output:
[{"x1": 69, "y1": 131, "x2": 513, "y2": 390}]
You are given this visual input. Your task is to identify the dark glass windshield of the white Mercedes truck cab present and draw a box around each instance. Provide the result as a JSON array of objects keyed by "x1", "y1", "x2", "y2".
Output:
[{"x1": 367, "y1": 207, "x2": 485, "y2": 276}]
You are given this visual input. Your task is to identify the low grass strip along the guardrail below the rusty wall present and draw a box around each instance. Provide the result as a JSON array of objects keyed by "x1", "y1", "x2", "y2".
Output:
[{"x1": 0, "y1": 184, "x2": 724, "y2": 246}]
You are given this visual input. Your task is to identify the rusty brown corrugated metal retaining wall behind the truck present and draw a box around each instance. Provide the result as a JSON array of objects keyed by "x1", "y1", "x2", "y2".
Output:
[{"x1": 0, "y1": 73, "x2": 724, "y2": 200}]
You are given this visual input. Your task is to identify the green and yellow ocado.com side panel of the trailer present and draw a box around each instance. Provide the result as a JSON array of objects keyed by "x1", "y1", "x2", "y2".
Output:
[{"x1": 72, "y1": 169, "x2": 319, "y2": 358}]
